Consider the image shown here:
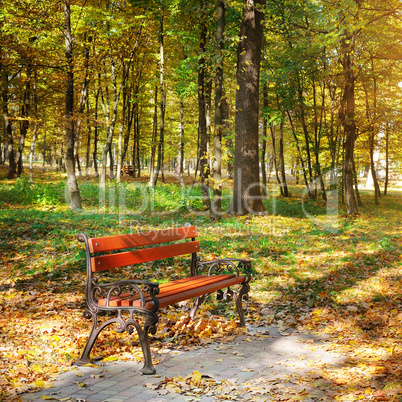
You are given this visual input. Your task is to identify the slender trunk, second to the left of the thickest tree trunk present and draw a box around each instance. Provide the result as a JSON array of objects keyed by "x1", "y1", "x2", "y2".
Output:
[{"x1": 198, "y1": 0, "x2": 211, "y2": 211}]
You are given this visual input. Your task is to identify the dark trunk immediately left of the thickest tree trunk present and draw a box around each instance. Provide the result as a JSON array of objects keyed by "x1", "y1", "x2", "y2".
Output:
[{"x1": 211, "y1": 0, "x2": 225, "y2": 220}]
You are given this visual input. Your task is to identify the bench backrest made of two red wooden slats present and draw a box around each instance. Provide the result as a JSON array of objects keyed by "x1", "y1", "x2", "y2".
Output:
[{"x1": 87, "y1": 226, "x2": 199, "y2": 272}]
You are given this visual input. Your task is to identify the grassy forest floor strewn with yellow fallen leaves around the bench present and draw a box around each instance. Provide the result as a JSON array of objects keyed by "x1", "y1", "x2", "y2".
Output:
[{"x1": 0, "y1": 168, "x2": 402, "y2": 401}]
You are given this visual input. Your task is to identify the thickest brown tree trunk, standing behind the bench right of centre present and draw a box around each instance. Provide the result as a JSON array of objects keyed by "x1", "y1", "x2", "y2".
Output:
[{"x1": 232, "y1": 0, "x2": 265, "y2": 215}]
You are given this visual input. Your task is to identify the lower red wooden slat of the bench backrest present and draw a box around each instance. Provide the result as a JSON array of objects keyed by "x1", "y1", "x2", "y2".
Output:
[{"x1": 91, "y1": 241, "x2": 200, "y2": 272}]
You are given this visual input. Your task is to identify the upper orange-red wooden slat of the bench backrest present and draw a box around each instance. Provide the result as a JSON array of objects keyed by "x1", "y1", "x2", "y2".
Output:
[{"x1": 88, "y1": 226, "x2": 197, "y2": 253}]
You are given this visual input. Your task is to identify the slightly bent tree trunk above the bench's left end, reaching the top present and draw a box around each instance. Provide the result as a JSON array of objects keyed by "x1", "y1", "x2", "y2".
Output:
[{"x1": 64, "y1": 0, "x2": 82, "y2": 211}]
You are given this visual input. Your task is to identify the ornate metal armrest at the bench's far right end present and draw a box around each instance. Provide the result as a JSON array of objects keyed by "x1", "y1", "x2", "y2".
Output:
[{"x1": 195, "y1": 258, "x2": 251, "y2": 283}]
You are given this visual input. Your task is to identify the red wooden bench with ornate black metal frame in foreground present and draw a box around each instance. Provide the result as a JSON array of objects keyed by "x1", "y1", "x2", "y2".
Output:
[{"x1": 76, "y1": 226, "x2": 251, "y2": 374}]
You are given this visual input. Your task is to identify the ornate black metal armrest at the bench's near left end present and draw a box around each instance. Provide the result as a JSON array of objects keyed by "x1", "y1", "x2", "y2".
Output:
[{"x1": 87, "y1": 278, "x2": 159, "y2": 311}]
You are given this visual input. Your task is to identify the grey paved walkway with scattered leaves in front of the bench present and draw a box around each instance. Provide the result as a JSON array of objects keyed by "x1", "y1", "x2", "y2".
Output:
[{"x1": 20, "y1": 327, "x2": 344, "y2": 402}]
